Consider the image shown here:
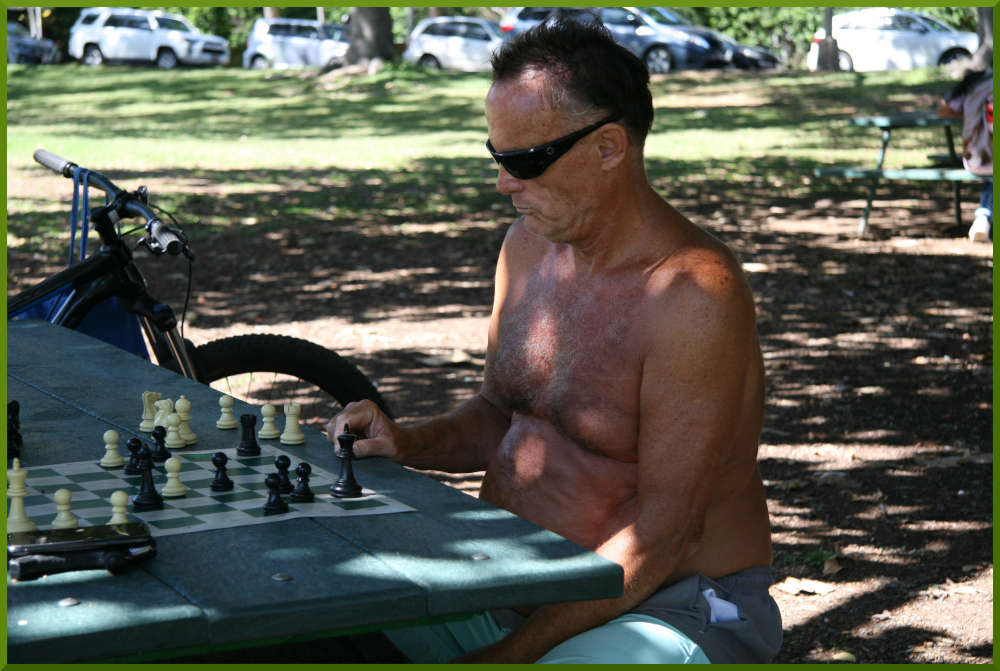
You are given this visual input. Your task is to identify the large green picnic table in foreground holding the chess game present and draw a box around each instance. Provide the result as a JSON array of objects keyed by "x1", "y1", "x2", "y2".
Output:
[{"x1": 6, "y1": 320, "x2": 622, "y2": 663}]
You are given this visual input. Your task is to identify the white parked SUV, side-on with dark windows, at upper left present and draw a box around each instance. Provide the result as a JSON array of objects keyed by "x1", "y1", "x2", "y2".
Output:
[{"x1": 68, "y1": 7, "x2": 229, "y2": 68}]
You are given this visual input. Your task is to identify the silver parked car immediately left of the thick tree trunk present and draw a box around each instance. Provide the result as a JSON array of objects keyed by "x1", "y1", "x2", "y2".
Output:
[{"x1": 243, "y1": 18, "x2": 350, "y2": 70}]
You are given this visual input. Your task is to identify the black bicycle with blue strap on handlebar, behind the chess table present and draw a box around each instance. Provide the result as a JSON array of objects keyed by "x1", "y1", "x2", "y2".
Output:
[{"x1": 7, "y1": 149, "x2": 388, "y2": 424}]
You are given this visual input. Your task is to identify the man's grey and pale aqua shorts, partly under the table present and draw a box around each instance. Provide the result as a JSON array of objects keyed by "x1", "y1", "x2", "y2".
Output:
[{"x1": 385, "y1": 567, "x2": 782, "y2": 664}]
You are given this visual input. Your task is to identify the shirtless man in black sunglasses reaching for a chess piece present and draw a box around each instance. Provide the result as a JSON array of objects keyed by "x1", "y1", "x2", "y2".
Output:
[{"x1": 327, "y1": 18, "x2": 781, "y2": 663}]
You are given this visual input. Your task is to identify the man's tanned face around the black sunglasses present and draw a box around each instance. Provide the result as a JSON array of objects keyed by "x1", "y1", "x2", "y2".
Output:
[{"x1": 486, "y1": 73, "x2": 596, "y2": 242}]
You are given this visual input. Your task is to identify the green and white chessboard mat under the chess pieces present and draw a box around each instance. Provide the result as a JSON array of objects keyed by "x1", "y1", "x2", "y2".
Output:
[{"x1": 15, "y1": 444, "x2": 413, "y2": 536}]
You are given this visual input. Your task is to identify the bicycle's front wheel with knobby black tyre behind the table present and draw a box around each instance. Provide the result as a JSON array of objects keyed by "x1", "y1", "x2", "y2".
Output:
[{"x1": 195, "y1": 334, "x2": 389, "y2": 430}]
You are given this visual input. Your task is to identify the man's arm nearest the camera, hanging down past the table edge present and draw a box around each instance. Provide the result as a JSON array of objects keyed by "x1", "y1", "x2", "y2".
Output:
[{"x1": 460, "y1": 253, "x2": 759, "y2": 662}]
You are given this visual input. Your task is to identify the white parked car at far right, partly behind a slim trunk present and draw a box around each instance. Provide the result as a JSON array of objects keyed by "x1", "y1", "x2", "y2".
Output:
[{"x1": 806, "y1": 7, "x2": 979, "y2": 72}]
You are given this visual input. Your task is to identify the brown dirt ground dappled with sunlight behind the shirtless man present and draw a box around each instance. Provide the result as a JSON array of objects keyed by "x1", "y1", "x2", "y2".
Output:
[{"x1": 8, "y1": 164, "x2": 993, "y2": 664}]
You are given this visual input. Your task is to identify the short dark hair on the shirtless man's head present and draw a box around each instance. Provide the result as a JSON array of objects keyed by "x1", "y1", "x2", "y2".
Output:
[{"x1": 493, "y1": 20, "x2": 653, "y2": 147}]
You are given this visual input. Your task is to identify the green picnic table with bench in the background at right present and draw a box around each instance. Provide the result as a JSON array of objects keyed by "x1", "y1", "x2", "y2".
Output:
[{"x1": 814, "y1": 112, "x2": 982, "y2": 237}]
